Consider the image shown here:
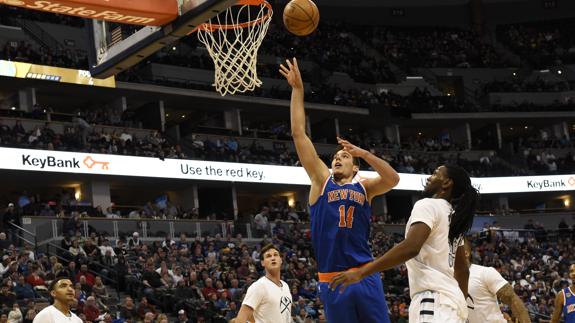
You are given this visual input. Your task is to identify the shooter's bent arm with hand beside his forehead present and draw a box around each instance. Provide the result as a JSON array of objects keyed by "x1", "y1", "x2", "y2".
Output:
[{"x1": 337, "y1": 138, "x2": 399, "y2": 202}]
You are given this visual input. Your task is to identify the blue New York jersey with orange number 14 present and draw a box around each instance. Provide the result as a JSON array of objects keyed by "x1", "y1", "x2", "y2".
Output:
[{"x1": 310, "y1": 176, "x2": 373, "y2": 273}]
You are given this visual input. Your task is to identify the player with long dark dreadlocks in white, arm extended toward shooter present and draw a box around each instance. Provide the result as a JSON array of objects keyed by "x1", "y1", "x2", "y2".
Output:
[{"x1": 330, "y1": 166, "x2": 479, "y2": 323}]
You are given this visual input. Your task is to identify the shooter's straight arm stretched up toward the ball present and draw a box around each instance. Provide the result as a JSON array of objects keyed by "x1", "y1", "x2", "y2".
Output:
[{"x1": 280, "y1": 58, "x2": 330, "y2": 189}]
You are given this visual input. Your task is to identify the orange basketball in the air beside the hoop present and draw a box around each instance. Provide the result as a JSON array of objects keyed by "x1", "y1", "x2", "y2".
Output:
[{"x1": 284, "y1": 0, "x2": 319, "y2": 36}]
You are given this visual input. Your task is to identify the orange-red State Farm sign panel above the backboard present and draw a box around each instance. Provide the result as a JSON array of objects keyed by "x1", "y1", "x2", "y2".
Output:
[{"x1": 0, "y1": 0, "x2": 178, "y2": 26}]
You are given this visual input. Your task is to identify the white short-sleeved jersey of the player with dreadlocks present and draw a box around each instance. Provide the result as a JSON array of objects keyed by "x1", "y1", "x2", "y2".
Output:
[{"x1": 405, "y1": 198, "x2": 467, "y2": 319}]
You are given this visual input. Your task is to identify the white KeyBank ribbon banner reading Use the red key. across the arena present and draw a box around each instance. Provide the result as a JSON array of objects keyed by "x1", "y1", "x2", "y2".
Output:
[{"x1": 0, "y1": 148, "x2": 575, "y2": 194}]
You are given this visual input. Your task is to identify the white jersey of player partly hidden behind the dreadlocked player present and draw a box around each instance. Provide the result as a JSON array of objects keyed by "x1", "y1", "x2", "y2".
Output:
[{"x1": 468, "y1": 265, "x2": 507, "y2": 323}]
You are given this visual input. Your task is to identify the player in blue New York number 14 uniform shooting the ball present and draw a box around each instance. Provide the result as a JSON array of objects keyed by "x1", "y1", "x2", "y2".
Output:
[{"x1": 280, "y1": 58, "x2": 399, "y2": 323}]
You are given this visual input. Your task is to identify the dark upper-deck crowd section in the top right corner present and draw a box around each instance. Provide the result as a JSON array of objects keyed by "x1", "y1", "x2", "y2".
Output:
[{"x1": 497, "y1": 19, "x2": 575, "y2": 68}]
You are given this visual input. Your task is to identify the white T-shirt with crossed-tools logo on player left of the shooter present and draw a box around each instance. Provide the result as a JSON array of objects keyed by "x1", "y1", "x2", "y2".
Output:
[{"x1": 242, "y1": 276, "x2": 292, "y2": 323}]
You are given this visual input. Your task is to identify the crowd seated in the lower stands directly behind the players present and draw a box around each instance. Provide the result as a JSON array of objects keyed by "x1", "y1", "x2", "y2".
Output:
[{"x1": 0, "y1": 213, "x2": 575, "y2": 322}]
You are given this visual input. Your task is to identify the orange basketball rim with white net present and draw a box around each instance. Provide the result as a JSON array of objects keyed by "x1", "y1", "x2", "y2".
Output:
[{"x1": 197, "y1": 0, "x2": 273, "y2": 96}]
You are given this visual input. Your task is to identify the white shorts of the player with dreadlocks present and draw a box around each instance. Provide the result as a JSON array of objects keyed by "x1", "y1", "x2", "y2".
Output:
[{"x1": 409, "y1": 291, "x2": 467, "y2": 323}]
